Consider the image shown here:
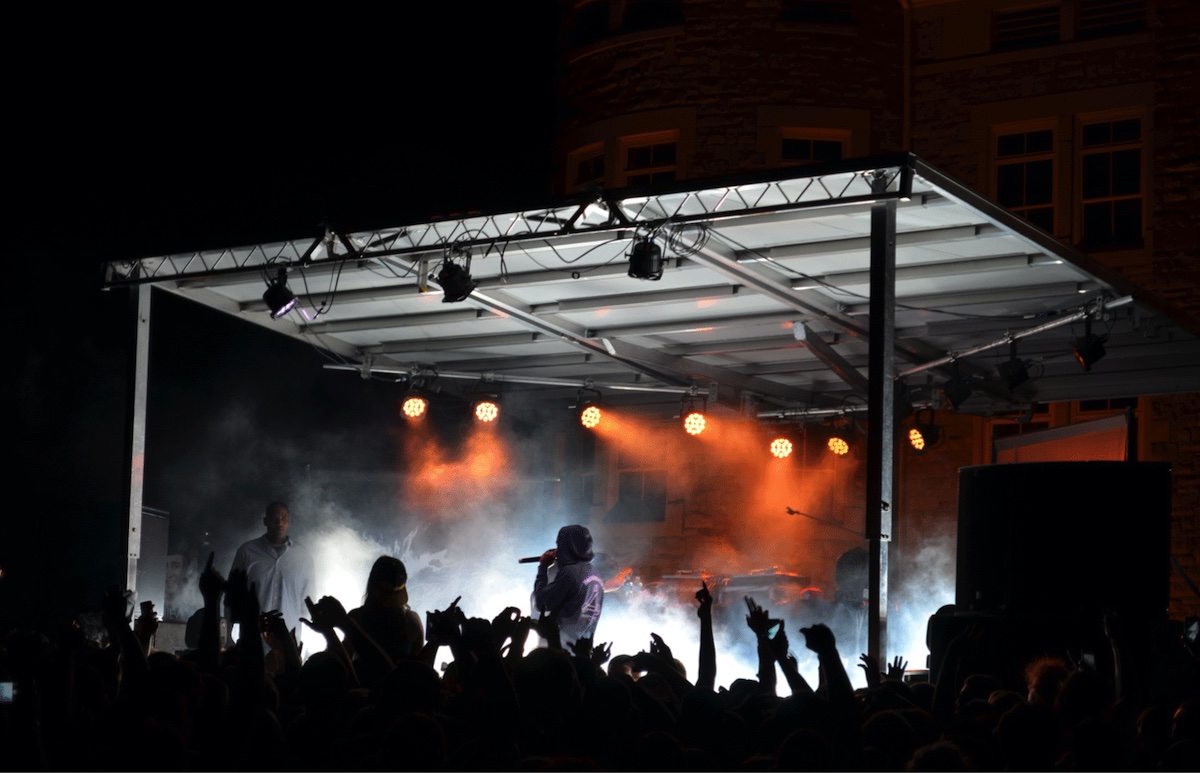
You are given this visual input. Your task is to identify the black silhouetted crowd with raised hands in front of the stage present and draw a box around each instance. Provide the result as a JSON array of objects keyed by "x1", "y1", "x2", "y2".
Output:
[{"x1": 0, "y1": 557, "x2": 1200, "y2": 771}]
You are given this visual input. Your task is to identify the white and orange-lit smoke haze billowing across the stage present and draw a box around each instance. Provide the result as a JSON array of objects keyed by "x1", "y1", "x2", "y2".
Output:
[{"x1": 152, "y1": 386, "x2": 954, "y2": 689}]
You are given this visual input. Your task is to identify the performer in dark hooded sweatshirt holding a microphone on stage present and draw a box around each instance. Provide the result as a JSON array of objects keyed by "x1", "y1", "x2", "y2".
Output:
[{"x1": 533, "y1": 525, "x2": 604, "y2": 651}]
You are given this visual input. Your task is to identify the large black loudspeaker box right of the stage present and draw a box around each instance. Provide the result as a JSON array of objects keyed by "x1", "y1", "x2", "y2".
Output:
[{"x1": 955, "y1": 462, "x2": 1171, "y2": 623}]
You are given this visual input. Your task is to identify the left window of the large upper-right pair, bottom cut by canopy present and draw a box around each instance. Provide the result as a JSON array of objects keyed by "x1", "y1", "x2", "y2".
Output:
[{"x1": 992, "y1": 127, "x2": 1055, "y2": 234}]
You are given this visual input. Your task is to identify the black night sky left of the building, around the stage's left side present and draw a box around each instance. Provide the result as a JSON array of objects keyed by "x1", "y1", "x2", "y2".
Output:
[{"x1": 9, "y1": 7, "x2": 554, "y2": 628}]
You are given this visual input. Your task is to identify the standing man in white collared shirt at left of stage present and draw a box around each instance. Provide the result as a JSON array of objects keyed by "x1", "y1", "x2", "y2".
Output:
[{"x1": 226, "y1": 502, "x2": 316, "y2": 648}]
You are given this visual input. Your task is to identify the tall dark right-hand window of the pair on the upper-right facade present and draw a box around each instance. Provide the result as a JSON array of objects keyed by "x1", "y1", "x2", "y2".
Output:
[{"x1": 1080, "y1": 118, "x2": 1142, "y2": 248}]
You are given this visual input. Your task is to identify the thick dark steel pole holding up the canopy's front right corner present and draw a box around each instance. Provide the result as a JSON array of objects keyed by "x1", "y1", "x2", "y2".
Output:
[{"x1": 864, "y1": 193, "x2": 896, "y2": 664}]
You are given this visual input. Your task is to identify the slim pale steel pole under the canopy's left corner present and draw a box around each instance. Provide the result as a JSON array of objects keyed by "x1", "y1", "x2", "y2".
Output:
[{"x1": 125, "y1": 284, "x2": 151, "y2": 592}]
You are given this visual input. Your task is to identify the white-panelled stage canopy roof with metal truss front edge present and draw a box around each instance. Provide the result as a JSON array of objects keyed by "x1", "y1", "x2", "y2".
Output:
[{"x1": 106, "y1": 154, "x2": 1200, "y2": 421}]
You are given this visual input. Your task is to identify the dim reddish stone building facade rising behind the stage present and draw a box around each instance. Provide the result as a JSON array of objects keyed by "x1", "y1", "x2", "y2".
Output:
[{"x1": 554, "y1": 0, "x2": 1200, "y2": 618}]
